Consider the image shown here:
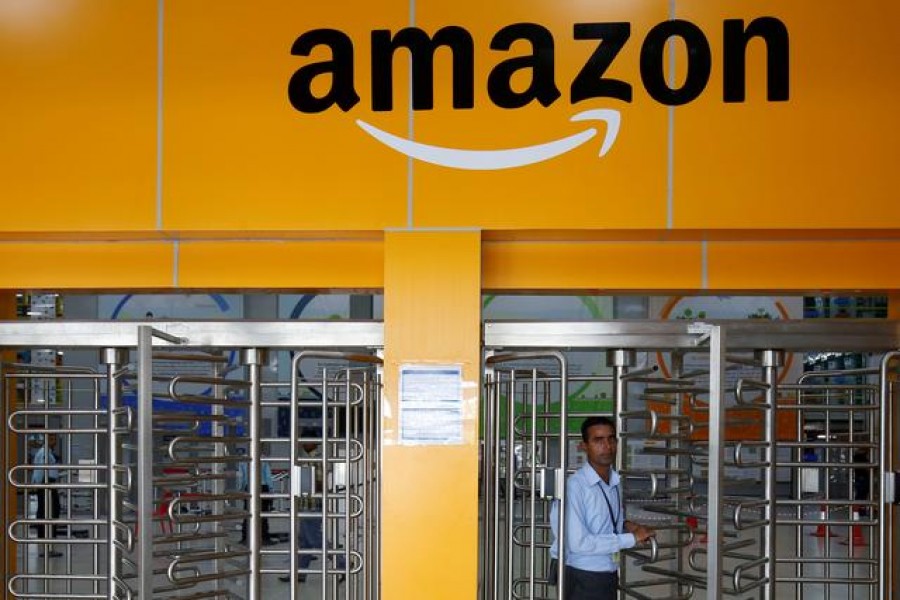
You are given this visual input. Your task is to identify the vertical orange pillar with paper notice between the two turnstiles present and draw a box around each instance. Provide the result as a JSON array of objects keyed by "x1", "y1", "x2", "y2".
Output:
[{"x1": 381, "y1": 231, "x2": 481, "y2": 600}]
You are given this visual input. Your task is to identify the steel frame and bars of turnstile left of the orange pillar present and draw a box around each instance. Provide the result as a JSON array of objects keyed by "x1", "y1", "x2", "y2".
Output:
[{"x1": 0, "y1": 321, "x2": 384, "y2": 600}]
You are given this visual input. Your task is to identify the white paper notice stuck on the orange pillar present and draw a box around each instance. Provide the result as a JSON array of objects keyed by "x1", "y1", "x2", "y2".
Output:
[{"x1": 400, "y1": 365, "x2": 463, "y2": 446}]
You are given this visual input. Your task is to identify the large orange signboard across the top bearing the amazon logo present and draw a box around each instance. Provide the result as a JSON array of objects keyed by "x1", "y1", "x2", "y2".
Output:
[{"x1": 0, "y1": 0, "x2": 900, "y2": 237}]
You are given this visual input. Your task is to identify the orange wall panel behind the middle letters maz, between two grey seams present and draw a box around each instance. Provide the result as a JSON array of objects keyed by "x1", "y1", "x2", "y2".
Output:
[{"x1": 412, "y1": 0, "x2": 668, "y2": 229}]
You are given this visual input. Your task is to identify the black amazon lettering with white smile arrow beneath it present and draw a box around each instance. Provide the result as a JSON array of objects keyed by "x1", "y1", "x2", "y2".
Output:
[{"x1": 288, "y1": 17, "x2": 790, "y2": 170}]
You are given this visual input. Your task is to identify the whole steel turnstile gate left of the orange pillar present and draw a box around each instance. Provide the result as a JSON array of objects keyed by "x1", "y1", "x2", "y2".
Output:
[{"x1": 0, "y1": 322, "x2": 383, "y2": 600}]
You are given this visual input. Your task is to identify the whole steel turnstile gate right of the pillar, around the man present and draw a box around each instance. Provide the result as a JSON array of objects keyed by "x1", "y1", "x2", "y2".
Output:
[{"x1": 481, "y1": 321, "x2": 900, "y2": 600}]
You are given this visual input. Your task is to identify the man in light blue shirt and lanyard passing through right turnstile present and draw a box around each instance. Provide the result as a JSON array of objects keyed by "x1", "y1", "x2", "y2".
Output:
[{"x1": 550, "y1": 417, "x2": 655, "y2": 600}]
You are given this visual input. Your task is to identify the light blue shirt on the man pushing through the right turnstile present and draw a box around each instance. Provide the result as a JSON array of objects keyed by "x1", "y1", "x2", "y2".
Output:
[{"x1": 550, "y1": 463, "x2": 635, "y2": 573}]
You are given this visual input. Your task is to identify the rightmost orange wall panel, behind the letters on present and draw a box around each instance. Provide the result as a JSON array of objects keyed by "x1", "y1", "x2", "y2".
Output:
[{"x1": 673, "y1": 0, "x2": 900, "y2": 229}]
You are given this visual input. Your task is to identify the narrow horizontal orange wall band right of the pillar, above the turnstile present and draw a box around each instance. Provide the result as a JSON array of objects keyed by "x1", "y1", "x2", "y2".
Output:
[{"x1": 483, "y1": 240, "x2": 900, "y2": 293}]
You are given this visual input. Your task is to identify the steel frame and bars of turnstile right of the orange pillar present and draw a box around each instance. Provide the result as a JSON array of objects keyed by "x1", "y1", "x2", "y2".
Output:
[{"x1": 481, "y1": 320, "x2": 900, "y2": 599}]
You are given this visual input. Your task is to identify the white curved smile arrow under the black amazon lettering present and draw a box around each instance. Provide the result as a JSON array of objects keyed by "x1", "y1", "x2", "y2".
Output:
[{"x1": 356, "y1": 108, "x2": 621, "y2": 171}]
